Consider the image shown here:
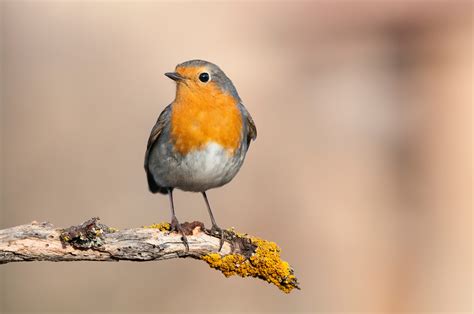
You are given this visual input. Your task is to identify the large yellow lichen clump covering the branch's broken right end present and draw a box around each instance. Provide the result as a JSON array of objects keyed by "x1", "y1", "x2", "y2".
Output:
[{"x1": 202, "y1": 234, "x2": 299, "y2": 293}]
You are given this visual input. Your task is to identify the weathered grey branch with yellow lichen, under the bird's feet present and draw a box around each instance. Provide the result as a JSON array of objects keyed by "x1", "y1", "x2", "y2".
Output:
[{"x1": 0, "y1": 218, "x2": 299, "y2": 293}]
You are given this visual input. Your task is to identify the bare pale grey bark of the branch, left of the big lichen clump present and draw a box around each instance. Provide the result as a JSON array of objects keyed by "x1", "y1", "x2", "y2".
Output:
[{"x1": 0, "y1": 219, "x2": 231, "y2": 264}]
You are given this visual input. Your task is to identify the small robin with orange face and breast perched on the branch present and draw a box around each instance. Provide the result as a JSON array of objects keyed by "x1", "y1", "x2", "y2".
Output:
[{"x1": 145, "y1": 60, "x2": 257, "y2": 250}]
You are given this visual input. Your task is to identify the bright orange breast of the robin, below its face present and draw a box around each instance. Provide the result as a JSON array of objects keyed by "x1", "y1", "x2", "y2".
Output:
[{"x1": 171, "y1": 84, "x2": 242, "y2": 155}]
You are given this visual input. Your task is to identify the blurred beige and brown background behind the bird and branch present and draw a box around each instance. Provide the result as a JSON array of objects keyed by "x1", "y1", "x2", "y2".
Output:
[{"x1": 0, "y1": 1, "x2": 473, "y2": 313}]
